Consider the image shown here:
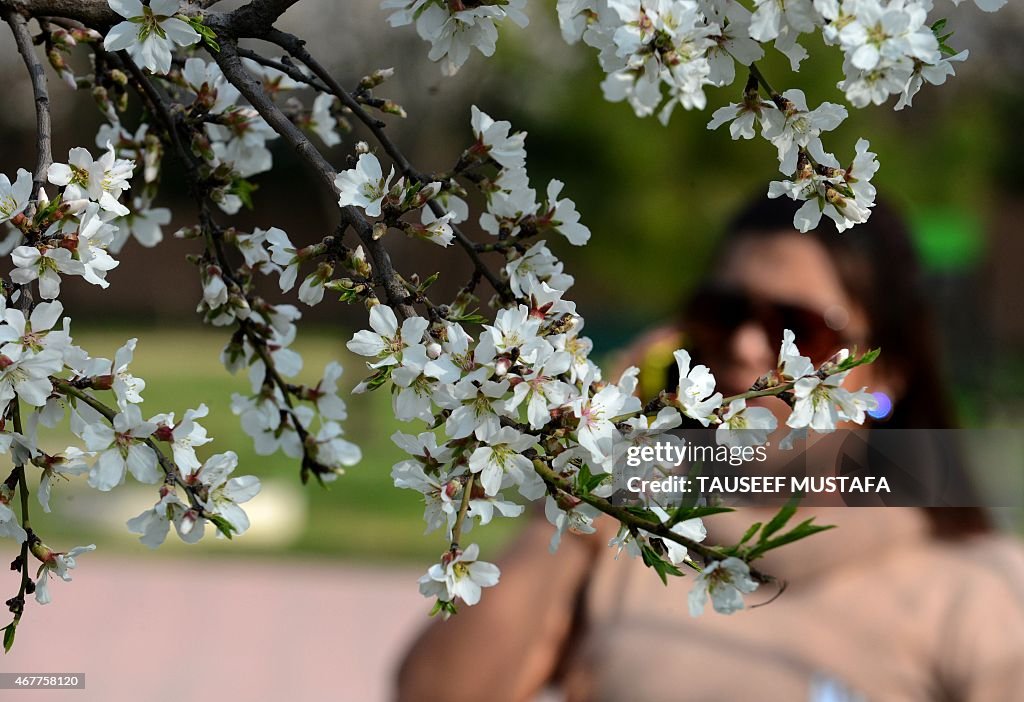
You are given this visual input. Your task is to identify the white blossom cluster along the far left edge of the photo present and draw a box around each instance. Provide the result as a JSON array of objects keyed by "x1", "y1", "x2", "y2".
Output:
[{"x1": 0, "y1": 148, "x2": 259, "y2": 604}]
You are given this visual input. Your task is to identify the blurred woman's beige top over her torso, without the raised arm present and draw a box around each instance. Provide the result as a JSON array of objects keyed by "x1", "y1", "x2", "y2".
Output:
[{"x1": 564, "y1": 508, "x2": 1024, "y2": 702}]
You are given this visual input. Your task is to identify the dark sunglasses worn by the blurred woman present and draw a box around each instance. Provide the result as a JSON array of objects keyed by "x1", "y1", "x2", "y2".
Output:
[{"x1": 683, "y1": 287, "x2": 852, "y2": 365}]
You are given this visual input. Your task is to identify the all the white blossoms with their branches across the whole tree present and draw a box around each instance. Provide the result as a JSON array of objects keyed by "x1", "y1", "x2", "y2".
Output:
[{"x1": 0, "y1": 0, "x2": 942, "y2": 646}]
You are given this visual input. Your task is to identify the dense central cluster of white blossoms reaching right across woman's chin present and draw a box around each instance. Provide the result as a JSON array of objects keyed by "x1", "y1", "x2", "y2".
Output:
[{"x1": 325, "y1": 107, "x2": 873, "y2": 612}]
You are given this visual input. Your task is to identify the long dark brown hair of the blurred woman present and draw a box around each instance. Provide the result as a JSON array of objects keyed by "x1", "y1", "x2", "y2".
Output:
[{"x1": 688, "y1": 195, "x2": 991, "y2": 537}]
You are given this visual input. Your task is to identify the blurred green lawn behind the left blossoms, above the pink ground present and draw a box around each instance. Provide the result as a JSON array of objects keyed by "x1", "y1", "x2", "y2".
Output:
[{"x1": 30, "y1": 328, "x2": 518, "y2": 562}]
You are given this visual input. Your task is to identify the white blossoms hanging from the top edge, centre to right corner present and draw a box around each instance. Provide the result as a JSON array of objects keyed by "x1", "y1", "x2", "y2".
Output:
[{"x1": 382, "y1": 0, "x2": 1006, "y2": 231}]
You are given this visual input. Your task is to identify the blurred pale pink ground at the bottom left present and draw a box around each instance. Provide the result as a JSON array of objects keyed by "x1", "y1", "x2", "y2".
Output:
[{"x1": 0, "y1": 554, "x2": 430, "y2": 702}]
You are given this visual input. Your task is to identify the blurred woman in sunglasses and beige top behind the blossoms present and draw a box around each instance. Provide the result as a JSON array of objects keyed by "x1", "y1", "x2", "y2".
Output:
[{"x1": 398, "y1": 196, "x2": 1024, "y2": 702}]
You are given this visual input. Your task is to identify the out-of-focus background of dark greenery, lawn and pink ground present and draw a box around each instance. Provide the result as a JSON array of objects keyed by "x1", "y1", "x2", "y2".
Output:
[{"x1": 0, "y1": 0, "x2": 1024, "y2": 700}]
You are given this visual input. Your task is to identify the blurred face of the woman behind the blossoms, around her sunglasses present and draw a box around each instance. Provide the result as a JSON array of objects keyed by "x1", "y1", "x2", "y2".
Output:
[{"x1": 697, "y1": 231, "x2": 872, "y2": 424}]
